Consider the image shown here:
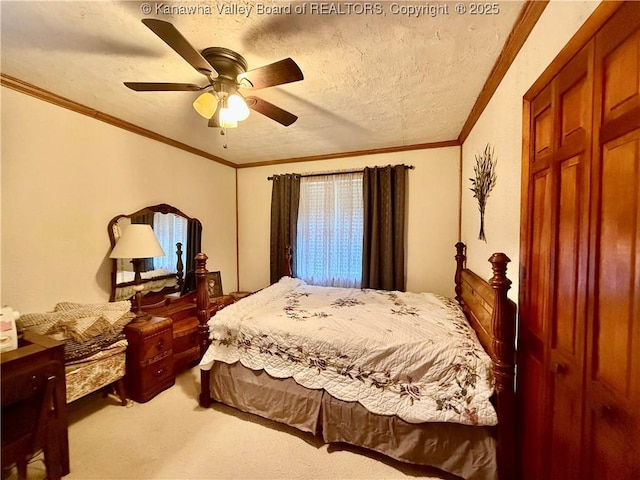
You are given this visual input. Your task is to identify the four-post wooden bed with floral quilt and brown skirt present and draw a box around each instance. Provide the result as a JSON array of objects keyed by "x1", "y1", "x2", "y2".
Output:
[{"x1": 196, "y1": 243, "x2": 515, "y2": 480}]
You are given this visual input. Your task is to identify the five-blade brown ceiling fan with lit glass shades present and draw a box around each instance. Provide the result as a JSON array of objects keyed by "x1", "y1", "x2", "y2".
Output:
[{"x1": 124, "y1": 18, "x2": 304, "y2": 129}]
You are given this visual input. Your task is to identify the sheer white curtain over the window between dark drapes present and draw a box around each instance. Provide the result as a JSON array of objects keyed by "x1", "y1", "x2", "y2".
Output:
[{"x1": 295, "y1": 172, "x2": 363, "y2": 288}]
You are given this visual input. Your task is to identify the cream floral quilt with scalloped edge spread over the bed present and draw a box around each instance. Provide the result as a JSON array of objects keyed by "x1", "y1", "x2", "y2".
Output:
[{"x1": 200, "y1": 277, "x2": 497, "y2": 425}]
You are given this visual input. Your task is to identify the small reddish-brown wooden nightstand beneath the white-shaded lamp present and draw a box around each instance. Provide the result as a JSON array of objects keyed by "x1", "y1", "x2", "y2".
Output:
[{"x1": 124, "y1": 317, "x2": 175, "y2": 403}]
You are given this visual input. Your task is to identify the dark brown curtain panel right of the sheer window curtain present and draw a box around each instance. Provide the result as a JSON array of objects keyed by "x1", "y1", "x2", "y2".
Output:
[{"x1": 362, "y1": 165, "x2": 407, "y2": 291}]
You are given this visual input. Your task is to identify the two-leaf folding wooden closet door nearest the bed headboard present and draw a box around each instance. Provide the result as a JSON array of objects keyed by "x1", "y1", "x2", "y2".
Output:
[{"x1": 519, "y1": 45, "x2": 593, "y2": 480}]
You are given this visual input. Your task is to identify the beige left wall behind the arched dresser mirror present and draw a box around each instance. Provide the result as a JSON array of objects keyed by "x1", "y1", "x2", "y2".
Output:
[{"x1": 1, "y1": 88, "x2": 236, "y2": 313}]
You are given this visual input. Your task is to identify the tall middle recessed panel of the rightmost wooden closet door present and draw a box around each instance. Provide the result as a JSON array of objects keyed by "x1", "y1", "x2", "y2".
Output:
[{"x1": 590, "y1": 133, "x2": 640, "y2": 398}]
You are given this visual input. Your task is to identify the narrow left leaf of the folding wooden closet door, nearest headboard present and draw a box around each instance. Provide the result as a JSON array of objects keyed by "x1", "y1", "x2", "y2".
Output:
[{"x1": 517, "y1": 82, "x2": 554, "y2": 480}]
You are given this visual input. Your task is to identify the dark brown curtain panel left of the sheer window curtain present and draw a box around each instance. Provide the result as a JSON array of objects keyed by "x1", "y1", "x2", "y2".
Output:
[{"x1": 271, "y1": 174, "x2": 300, "y2": 284}]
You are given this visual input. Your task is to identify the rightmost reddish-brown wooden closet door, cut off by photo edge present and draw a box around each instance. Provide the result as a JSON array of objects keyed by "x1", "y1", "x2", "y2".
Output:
[{"x1": 584, "y1": 2, "x2": 640, "y2": 480}]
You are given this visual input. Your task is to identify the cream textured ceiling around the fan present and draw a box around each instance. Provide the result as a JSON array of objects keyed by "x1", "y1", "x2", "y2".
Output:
[{"x1": 0, "y1": 1, "x2": 524, "y2": 164}]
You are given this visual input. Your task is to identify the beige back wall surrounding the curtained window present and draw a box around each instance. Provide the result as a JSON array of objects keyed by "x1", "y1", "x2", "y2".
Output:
[{"x1": 238, "y1": 147, "x2": 460, "y2": 295}]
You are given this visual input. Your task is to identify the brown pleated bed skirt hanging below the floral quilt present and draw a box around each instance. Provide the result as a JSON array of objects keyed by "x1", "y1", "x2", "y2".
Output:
[{"x1": 209, "y1": 362, "x2": 497, "y2": 480}]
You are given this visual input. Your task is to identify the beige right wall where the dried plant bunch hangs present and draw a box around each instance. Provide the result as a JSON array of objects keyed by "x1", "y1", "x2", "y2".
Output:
[{"x1": 462, "y1": 1, "x2": 599, "y2": 299}]
